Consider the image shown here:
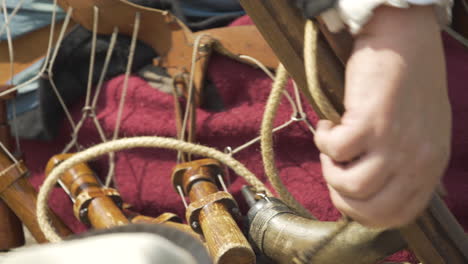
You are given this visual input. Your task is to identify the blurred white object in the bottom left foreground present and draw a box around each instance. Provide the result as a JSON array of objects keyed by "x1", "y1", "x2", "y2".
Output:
[{"x1": 0, "y1": 233, "x2": 196, "y2": 264}]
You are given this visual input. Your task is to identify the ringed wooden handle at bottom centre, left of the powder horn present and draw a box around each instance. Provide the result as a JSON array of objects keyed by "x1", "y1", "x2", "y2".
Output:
[{"x1": 173, "y1": 159, "x2": 255, "y2": 264}]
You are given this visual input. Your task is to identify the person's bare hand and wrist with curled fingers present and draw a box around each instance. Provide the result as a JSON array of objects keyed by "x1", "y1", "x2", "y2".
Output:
[{"x1": 315, "y1": 6, "x2": 451, "y2": 228}]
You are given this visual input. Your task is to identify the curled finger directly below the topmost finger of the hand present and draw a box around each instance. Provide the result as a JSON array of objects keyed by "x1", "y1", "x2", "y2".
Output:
[{"x1": 320, "y1": 153, "x2": 392, "y2": 200}]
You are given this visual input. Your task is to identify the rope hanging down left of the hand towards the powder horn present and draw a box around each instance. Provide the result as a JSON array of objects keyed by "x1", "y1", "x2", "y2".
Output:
[{"x1": 260, "y1": 64, "x2": 312, "y2": 218}]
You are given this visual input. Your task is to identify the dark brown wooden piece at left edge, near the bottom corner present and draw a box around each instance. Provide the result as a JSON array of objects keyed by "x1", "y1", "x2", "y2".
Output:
[{"x1": 0, "y1": 200, "x2": 24, "y2": 251}]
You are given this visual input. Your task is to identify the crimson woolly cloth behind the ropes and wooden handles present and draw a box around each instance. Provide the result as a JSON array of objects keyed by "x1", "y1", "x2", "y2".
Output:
[{"x1": 23, "y1": 18, "x2": 468, "y2": 260}]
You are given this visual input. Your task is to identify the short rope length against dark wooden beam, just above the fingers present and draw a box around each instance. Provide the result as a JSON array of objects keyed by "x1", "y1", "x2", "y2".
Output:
[{"x1": 304, "y1": 20, "x2": 341, "y2": 124}]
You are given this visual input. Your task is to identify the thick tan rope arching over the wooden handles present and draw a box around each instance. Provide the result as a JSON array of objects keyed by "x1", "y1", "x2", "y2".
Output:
[{"x1": 36, "y1": 137, "x2": 271, "y2": 242}]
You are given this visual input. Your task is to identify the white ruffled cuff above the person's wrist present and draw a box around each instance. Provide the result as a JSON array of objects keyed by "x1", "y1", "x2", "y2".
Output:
[{"x1": 322, "y1": 0, "x2": 453, "y2": 34}]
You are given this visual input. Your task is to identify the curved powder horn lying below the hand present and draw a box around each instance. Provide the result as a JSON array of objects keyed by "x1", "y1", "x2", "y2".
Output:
[{"x1": 242, "y1": 186, "x2": 406, "y2": 264}]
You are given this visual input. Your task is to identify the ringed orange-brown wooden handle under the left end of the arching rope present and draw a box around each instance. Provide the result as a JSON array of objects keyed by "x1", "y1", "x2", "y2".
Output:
[{"x1": 46, "y1": 154, "x2": 129, "y2": 229}]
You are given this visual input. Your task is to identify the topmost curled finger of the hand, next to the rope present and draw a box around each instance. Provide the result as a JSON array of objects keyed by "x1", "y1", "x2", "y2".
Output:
[{"x1": 315, "y1": 120, "x2": 368, "y2": 162}]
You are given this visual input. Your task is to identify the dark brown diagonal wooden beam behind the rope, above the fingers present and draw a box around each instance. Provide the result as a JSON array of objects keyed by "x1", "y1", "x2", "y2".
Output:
[{"x1": 240, "y1": 0, "x2": 344, "y2": 118}]
